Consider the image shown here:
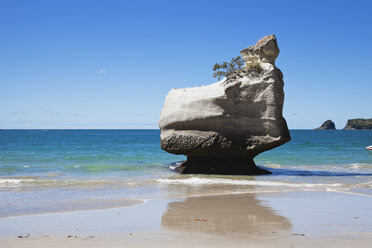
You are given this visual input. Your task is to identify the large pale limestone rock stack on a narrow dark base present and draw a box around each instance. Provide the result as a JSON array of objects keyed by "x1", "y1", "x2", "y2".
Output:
[{"x1": 159, "y1": 35, "x2": 290, "y2": 174}]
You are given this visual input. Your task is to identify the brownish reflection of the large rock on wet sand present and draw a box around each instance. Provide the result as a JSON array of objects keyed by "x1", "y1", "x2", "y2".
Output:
[{"x1": 161, "y1": 194, "x2": 292, "y2": 234}]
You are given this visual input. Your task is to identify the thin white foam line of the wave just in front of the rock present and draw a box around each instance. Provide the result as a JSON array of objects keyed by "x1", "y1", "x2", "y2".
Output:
[{"x1": 157, "y1": 178, "x2": 342, "y2": 188}]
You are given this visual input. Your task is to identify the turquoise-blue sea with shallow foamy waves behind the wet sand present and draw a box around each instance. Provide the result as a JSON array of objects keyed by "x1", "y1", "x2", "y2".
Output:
[{"x1": 0, "y1": 130, "x2": 372, "y2": 217}]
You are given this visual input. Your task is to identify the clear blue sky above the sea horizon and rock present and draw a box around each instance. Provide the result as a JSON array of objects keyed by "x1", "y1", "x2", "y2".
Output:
[{"x1": 0, "y1": 0, "x2": 372, "y2": 129}]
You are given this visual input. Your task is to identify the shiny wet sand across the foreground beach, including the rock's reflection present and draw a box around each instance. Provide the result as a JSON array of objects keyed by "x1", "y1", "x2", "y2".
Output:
[{"x1": 0, "y1": 191, "x2": 372, "y2": 248}]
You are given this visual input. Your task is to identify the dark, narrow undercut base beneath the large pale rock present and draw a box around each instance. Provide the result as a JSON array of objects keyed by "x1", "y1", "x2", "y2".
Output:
[{"x1": 174, "y1": 156, "x2": 271, "y2": 175}]
